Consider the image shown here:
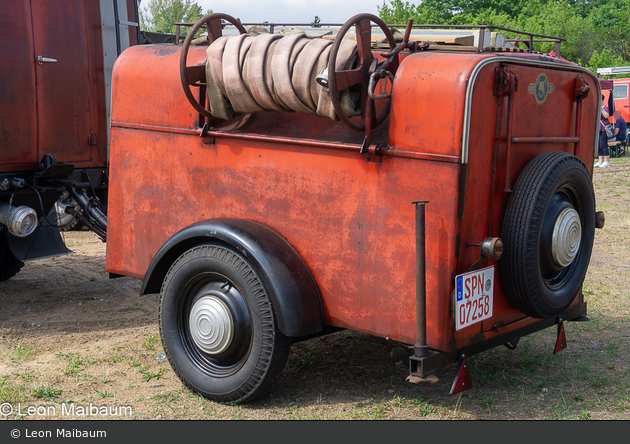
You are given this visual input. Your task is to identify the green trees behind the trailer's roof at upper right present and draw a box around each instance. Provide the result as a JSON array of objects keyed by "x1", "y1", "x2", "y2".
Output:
[{"x1": 377, "y1": 0, "x2": 630, "y2": 69}]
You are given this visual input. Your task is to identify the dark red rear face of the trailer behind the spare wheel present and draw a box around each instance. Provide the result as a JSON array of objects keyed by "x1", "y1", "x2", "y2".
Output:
[{"x1": 453, "y1": 64, "x2": 597, "y2": 344}]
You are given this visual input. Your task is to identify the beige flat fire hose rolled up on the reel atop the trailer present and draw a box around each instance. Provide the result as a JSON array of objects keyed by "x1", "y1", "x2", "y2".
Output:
[{"x1": 206, "y1": 34, "x2": 361, "y2": 120}]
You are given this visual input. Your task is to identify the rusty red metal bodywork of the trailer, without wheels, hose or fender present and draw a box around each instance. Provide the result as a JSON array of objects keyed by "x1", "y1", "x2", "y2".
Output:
[{"x1": 106, "y1": 20, "x2": 600, "y2": 398}]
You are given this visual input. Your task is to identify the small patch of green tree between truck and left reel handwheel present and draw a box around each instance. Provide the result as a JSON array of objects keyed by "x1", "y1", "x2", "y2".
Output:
[{"x1": 139, "y1": 0, "x2": 207, "y2": 34}]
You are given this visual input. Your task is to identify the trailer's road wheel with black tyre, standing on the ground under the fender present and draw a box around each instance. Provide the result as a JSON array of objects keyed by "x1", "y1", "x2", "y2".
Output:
[{"x1": 159, "y1": 244, "x2": 291, "y2": 404}]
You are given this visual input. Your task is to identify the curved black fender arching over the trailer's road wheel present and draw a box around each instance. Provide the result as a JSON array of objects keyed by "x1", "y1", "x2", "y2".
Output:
[{"x1": 140, "y1": 218, "x2": 324, "y2": 338}]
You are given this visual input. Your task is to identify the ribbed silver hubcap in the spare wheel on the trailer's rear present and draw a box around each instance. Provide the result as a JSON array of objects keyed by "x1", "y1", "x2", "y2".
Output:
[{"x1": 551, "y1": 208, "x2": 582, "y2": 267}]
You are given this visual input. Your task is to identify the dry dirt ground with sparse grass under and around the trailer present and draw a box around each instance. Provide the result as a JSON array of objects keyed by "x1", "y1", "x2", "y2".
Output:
[{"x1": 0, "y1": 159, "x2": 630, "y2": 420}]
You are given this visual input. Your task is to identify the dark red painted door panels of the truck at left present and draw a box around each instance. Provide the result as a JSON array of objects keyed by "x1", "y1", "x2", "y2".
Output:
[{"x1": 0, "y1": 0, "x2": 107, "y2": 171}]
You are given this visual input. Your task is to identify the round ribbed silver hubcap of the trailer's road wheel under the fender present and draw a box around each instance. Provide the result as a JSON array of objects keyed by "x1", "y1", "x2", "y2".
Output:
[{"x1": 189, "y1": 295, "x2": 234, "y2": 355}]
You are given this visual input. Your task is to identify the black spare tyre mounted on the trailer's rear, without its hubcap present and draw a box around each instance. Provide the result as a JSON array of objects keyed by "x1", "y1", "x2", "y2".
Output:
[{"x1": 499, "y1": 152, "x2": 595, "y2": 318}]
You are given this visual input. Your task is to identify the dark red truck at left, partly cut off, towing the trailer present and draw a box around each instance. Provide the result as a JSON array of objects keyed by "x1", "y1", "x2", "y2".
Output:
[{"x1": 0, "y1": 0, "x2": 140, "y2": 281}]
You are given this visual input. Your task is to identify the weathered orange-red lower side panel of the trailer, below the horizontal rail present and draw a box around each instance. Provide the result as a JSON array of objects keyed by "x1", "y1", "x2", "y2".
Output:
[{"x1": 107, "y1": 124, "x2": 457, "y2": 341}]
